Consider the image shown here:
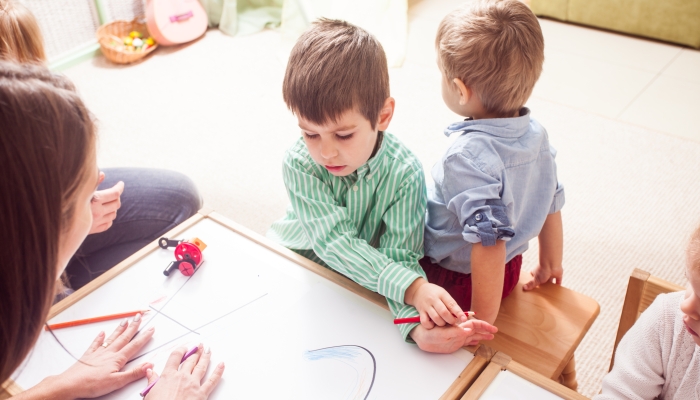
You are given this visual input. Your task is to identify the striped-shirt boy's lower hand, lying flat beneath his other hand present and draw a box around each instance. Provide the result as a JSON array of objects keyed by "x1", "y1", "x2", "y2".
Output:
[{"x1": 410, "y1": 319, "x2": 498, "y2": 353}]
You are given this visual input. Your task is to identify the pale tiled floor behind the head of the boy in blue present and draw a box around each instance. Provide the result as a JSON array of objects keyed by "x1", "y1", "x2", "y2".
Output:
[{"x1": 406, "y1": 0, "x2": 700, "y2": 141}]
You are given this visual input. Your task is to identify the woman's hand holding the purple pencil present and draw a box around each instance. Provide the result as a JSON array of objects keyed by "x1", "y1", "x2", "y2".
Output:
[{"x1": 145, "y1": 344, "x2": 224, "y2": 400}]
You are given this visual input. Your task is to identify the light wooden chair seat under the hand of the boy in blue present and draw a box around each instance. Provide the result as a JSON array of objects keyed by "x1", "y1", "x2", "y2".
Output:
[{"x1": 486, "y1": 271, "x2": 600, "y2": 390}]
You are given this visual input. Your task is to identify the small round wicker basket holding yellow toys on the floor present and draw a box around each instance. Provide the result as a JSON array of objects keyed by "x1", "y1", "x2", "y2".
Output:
[{"x1": 97, "y1": 18, "x2": 158, "y2": 64}]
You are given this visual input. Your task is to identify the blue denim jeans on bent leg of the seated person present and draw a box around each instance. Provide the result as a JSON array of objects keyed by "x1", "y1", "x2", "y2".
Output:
[{"x1": 66, "y1": 168, "x2": 202, "y2": 290}]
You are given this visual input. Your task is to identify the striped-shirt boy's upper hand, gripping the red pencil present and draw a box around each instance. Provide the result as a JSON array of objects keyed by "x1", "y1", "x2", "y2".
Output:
[{"x1": 404, "y1": 278, "x2": 467, "y2": 329}]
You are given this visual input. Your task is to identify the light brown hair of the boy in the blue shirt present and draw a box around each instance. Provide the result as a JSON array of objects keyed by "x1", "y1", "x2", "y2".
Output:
[{"x1": 435, "y1": 0, "x2": 544, "y2": 116}]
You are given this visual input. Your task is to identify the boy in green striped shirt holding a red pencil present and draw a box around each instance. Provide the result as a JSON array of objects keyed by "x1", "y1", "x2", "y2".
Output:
[{"x1": 268, "y1": 19, "x2": 496, "y2": 352}]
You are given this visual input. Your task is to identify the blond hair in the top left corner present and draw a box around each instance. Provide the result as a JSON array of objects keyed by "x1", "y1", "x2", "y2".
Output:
[{"x1": 0, "y1": 0, "x2": 46, "y2": 63}]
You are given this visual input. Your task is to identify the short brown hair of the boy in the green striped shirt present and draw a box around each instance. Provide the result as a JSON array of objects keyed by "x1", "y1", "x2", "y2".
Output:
[{"x1": 282, "y1": 18, "x2": 389, "y2": 129}]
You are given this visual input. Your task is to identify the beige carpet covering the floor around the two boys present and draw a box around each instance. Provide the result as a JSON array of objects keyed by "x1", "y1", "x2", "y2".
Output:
[{"x1": 66, "y1": 27, "x2": 700, "y2": 396}]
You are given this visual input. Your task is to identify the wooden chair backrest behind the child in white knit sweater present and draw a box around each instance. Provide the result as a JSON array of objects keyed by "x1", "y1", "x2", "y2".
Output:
[{"x1": 610, "y1": 268, "x2": 685, "y2": 369}]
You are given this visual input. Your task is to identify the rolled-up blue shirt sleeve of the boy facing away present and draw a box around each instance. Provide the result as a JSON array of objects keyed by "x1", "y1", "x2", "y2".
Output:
[{"x1": 442, "y1": 153, "x2": 515, "y2": 246}]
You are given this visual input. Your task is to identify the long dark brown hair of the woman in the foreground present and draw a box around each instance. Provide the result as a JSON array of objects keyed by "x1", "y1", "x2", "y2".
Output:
[{"x1": 0, "y1": 61, "x2": 95, "y2": 382}]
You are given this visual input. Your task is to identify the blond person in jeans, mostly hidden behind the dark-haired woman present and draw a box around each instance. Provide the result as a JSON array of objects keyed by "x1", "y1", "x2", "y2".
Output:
[{"x1": 0, "y1": 0, "x2": 202, "y2": 290}]
